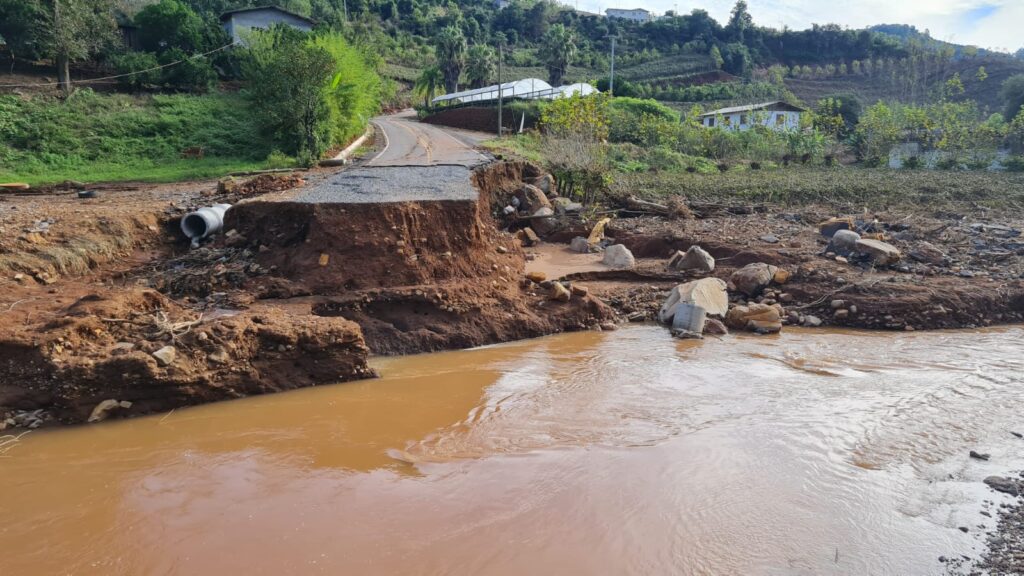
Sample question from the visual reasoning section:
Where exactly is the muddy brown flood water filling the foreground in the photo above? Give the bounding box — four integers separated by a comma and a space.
0, 326, 1024, 575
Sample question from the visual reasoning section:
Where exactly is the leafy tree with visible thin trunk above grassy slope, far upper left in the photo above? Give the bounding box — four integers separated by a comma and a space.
39, 0, 118, 94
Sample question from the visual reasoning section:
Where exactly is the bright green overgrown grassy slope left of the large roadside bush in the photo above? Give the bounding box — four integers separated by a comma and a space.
0, 90, 273, 184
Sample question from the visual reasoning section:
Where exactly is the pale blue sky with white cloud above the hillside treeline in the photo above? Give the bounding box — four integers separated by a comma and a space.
562, 0, 1024, 51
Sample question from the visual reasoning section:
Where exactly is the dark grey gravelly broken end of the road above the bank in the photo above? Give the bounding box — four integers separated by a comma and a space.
294, 165, 478, 204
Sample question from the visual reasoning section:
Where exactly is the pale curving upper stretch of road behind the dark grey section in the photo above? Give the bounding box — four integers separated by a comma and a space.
367, 111, 487, 167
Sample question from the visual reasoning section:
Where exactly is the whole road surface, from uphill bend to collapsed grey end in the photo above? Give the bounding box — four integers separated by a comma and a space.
293, 112, 487, 204
